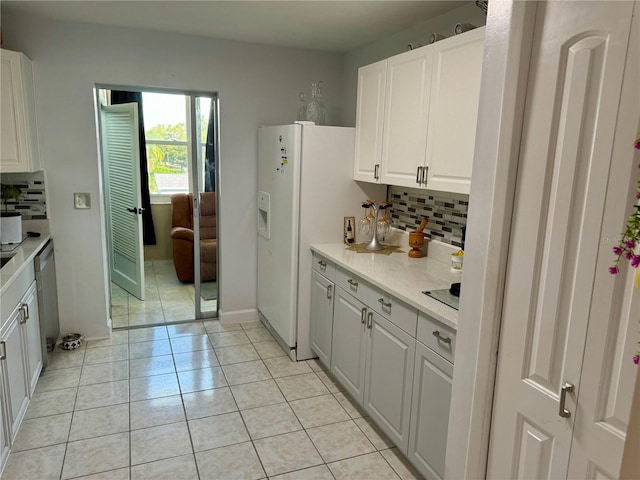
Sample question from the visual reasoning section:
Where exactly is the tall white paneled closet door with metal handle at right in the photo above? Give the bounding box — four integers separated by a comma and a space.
487, 2, 638, 479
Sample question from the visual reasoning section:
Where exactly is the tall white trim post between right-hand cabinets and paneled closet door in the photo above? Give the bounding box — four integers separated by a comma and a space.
445, 0, 536, 479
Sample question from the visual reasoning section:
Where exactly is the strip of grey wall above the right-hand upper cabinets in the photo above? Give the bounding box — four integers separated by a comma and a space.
342, 2, 487, 126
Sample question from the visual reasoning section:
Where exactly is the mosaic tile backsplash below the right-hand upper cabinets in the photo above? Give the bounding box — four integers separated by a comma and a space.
388, 186, 469, 247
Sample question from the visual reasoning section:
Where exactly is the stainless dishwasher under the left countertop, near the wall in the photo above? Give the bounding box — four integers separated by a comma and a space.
35, 240, 60, 369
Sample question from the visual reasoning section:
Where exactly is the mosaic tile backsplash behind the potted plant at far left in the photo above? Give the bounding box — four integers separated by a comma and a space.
1, 172, 47, 220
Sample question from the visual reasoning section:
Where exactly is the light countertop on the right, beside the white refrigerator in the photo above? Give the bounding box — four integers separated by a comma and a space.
311, 243, 459, 329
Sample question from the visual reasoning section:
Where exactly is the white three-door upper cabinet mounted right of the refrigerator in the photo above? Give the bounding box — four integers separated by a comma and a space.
354, 27, 485, 194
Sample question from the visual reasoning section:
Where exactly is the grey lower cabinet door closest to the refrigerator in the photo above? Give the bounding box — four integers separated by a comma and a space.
311, 272, 334, 367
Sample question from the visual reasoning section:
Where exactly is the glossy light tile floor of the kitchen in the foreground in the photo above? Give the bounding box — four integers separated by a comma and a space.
2, 320, 420, 480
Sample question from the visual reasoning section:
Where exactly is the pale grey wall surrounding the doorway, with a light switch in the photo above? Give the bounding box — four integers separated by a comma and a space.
2, 13, 342, 337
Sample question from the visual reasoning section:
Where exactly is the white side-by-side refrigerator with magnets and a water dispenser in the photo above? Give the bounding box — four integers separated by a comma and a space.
257, 124, 386, 360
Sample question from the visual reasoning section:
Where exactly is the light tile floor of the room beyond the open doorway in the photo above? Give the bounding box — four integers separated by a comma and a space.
111, 260, 217, 329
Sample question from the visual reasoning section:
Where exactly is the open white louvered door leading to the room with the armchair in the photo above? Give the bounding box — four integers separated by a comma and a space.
100, 103, 145, 300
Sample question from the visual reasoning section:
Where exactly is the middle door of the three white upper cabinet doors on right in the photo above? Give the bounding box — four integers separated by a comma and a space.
381, 47, 431, 187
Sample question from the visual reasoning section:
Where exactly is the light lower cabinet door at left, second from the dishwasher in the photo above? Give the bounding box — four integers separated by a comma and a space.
0, 307, 29, 440
